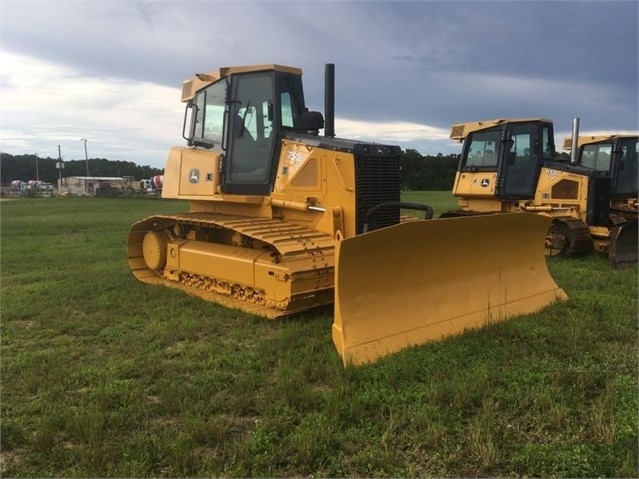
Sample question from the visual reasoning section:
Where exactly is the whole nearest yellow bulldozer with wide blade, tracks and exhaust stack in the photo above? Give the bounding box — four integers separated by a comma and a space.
127, 64, 566, 364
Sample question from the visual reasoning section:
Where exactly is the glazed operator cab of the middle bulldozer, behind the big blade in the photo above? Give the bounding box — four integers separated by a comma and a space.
451, 119, 554, 199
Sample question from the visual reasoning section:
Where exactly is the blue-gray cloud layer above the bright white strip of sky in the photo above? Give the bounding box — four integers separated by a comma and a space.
1, 1, 639, 165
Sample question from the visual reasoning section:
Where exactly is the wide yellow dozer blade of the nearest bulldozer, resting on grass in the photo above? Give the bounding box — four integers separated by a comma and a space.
333, 213, 567, 364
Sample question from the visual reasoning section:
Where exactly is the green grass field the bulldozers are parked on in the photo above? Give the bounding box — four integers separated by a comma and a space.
0, 192, 639, 477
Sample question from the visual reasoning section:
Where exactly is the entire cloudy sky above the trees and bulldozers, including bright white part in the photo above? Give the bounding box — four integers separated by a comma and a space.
0, 0, 639, 168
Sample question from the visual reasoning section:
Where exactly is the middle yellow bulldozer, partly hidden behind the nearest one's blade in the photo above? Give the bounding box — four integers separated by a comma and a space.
442, 118, 637, 267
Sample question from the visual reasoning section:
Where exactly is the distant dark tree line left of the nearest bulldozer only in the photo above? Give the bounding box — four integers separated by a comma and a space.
0, 153, 162, 185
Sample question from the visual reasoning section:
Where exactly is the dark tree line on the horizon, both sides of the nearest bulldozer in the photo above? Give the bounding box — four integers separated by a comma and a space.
0, 149, 459, 190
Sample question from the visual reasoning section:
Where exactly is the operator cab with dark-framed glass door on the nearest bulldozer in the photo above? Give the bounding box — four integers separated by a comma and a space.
183, 65, 323, 195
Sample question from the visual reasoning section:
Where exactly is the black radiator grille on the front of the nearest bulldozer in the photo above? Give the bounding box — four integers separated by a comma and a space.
355, 155, 400, 234
